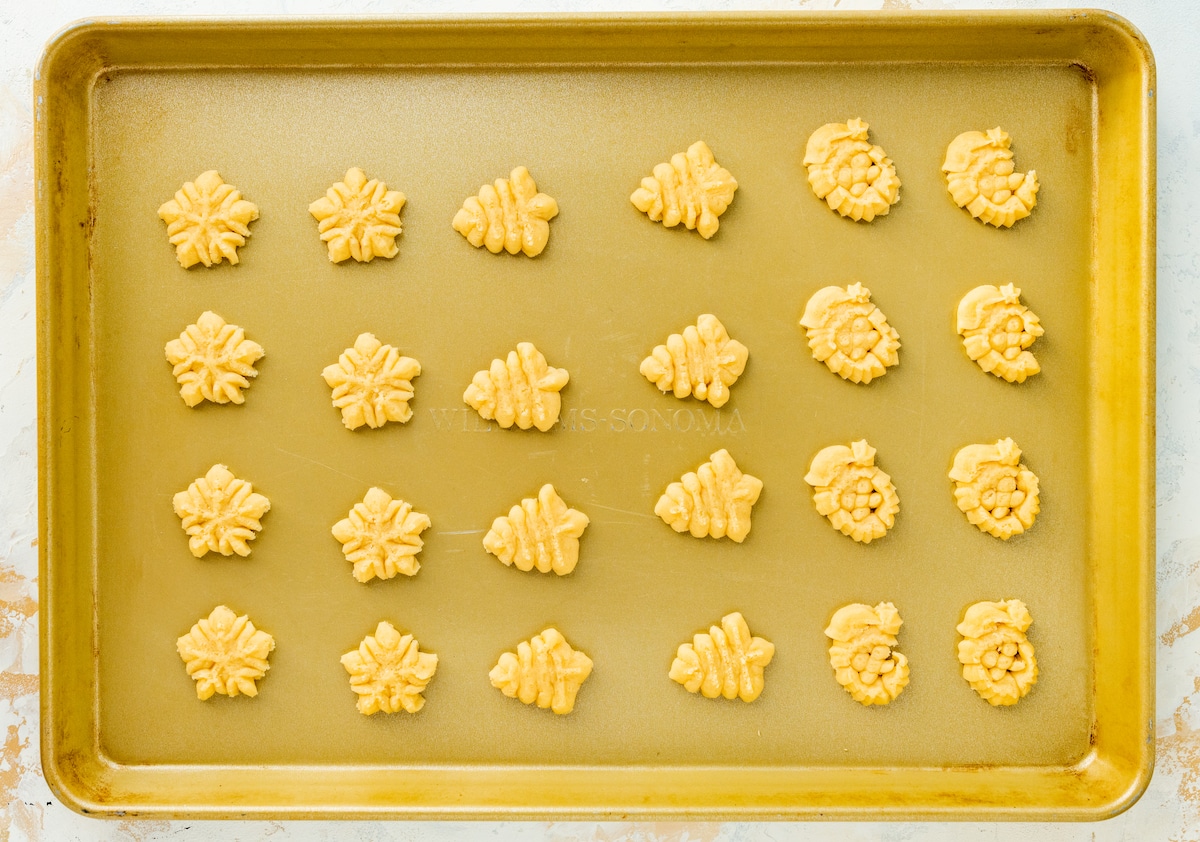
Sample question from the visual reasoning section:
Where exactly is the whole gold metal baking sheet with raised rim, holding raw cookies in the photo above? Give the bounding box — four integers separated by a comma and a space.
38, 13, 1153, 818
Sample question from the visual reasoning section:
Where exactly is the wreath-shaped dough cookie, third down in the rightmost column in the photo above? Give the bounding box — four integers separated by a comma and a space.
950, 439, 1042, 541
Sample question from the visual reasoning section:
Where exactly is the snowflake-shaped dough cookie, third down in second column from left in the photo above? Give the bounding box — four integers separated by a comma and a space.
332, 488, 430, 582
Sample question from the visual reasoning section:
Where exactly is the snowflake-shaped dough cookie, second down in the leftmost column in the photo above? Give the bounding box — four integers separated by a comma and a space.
163, 311, 264, 407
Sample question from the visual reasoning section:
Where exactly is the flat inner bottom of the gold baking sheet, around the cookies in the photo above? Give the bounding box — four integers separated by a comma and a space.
43, 11, 1152, 813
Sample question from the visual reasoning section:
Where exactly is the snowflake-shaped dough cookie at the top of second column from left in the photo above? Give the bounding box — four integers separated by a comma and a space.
308, 167, 404, 263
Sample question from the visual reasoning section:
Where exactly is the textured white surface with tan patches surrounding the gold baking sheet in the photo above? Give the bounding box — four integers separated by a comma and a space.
0, 0, 1200, 842
